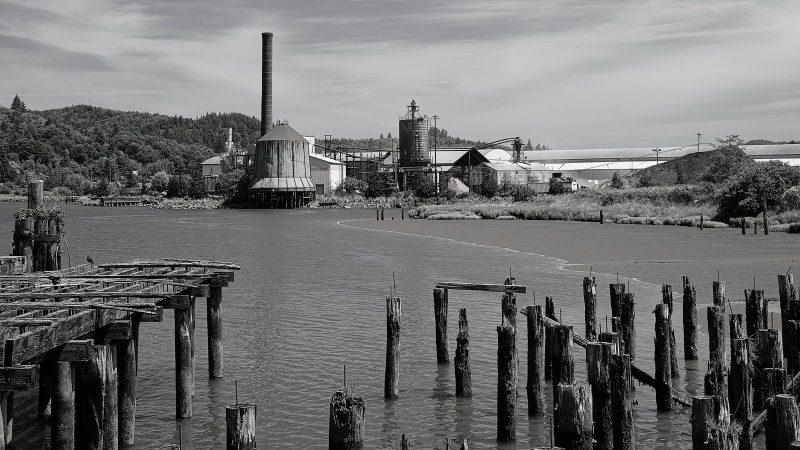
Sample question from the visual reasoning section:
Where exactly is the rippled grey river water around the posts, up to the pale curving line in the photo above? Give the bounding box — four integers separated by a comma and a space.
0, 204, 776, 449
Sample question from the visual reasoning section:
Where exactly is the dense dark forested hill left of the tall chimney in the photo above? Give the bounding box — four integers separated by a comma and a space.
0, 97, 259, 194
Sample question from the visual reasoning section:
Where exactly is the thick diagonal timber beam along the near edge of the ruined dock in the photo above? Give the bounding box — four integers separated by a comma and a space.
3, 309, 122, 367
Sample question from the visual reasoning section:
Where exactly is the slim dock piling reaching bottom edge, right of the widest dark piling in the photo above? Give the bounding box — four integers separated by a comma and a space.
117, 314, 140, 447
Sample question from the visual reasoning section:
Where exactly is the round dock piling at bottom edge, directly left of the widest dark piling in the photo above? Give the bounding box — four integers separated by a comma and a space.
50, 361, 75, 450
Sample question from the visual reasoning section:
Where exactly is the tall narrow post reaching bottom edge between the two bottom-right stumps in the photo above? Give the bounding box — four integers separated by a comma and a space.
728, 338, 753, 450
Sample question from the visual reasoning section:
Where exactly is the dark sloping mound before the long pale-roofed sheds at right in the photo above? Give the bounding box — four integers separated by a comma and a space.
626, 146, 755, 186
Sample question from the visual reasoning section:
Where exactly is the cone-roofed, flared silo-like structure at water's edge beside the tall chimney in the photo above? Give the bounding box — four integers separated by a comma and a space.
250, 123, 316, 208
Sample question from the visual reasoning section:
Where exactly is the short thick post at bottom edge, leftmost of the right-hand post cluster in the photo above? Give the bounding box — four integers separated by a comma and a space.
554, 383, 592, 450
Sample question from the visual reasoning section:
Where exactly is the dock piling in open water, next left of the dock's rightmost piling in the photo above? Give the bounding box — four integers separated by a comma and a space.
174, 309, 193, 419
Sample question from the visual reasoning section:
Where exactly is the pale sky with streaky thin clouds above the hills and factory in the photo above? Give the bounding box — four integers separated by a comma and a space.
0, 0, 800, 149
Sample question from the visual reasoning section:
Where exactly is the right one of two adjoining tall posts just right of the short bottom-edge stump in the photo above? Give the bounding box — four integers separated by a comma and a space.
608, 355, 636, 450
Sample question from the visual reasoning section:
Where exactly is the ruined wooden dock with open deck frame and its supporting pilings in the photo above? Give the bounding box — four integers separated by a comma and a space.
0, 260, 239, 448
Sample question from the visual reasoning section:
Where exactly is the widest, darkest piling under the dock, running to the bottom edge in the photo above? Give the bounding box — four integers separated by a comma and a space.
75, 345, 108, 450
